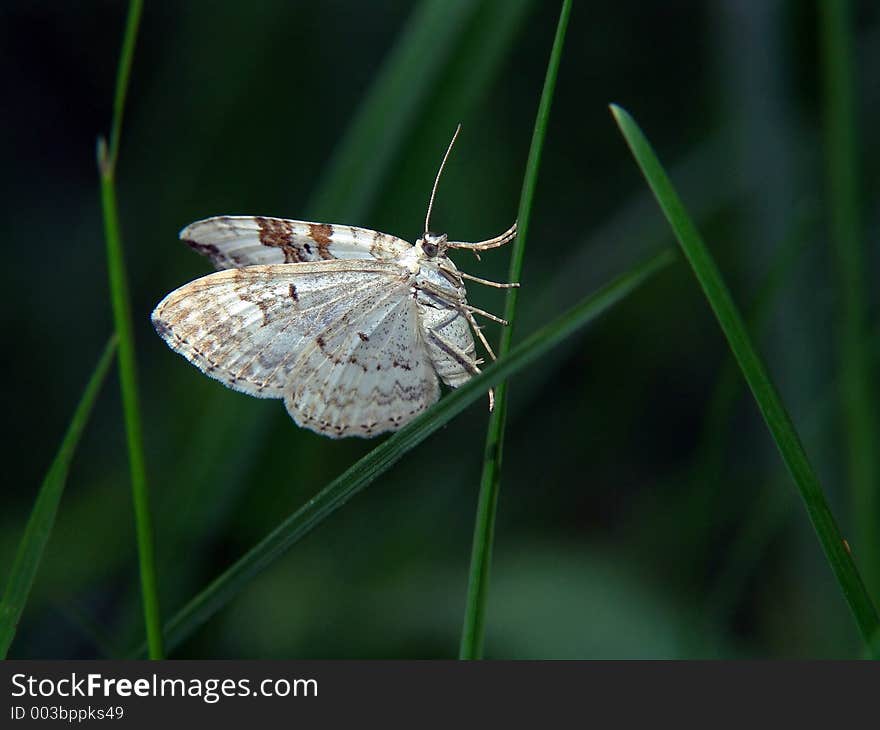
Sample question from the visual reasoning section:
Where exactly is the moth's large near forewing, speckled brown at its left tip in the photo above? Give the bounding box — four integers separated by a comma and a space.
152, 261, 408, 398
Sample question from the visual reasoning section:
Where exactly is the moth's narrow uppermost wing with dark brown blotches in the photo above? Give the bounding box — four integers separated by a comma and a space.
180, 216, 412, 269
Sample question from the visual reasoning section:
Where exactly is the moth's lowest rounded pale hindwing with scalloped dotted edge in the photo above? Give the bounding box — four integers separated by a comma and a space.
284, 286, 440, 437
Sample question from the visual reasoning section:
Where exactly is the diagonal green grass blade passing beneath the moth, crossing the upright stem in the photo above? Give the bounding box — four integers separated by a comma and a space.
134, 251, 674, 652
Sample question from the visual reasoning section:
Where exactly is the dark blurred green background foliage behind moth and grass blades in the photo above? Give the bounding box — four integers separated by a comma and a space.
0, 0, 880, 658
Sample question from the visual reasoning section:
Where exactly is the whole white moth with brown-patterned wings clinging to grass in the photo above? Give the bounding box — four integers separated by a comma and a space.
152, 125, 518, 438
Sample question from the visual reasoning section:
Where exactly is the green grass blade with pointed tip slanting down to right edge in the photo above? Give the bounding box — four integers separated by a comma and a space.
611, 105, 880, 650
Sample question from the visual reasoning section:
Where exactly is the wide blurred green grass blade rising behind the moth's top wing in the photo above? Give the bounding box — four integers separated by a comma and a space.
309, 0, 478, 221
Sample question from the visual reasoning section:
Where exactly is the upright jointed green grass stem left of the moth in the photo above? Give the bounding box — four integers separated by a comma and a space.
98, 0, 164, 659
